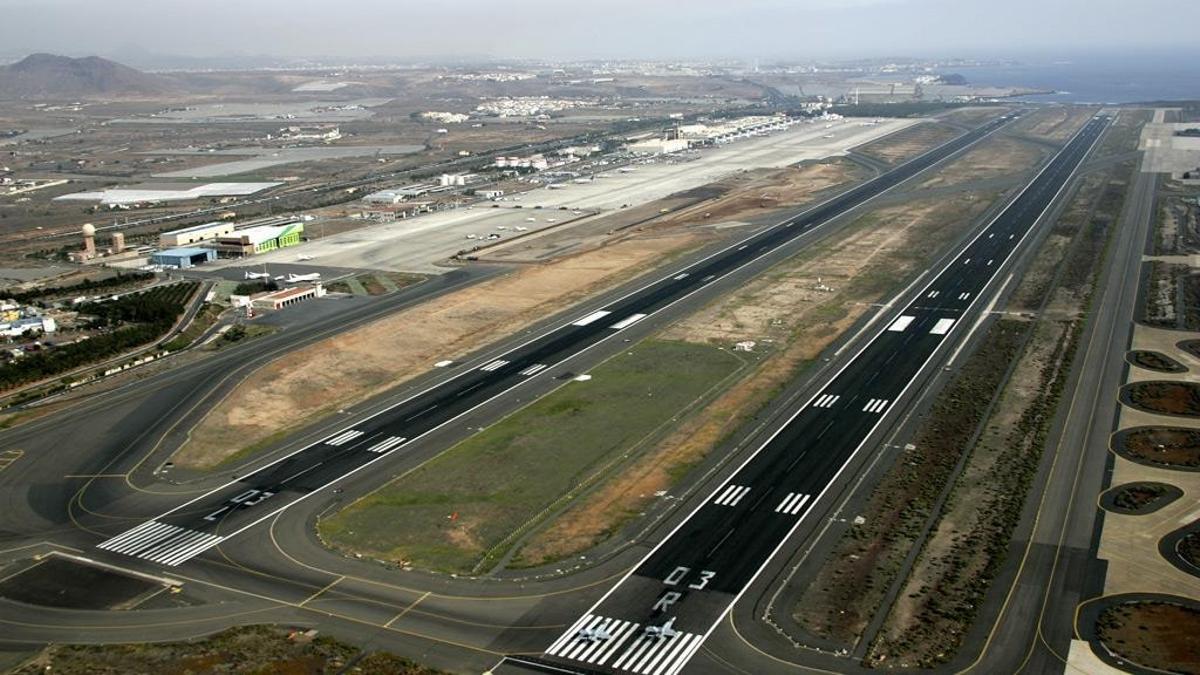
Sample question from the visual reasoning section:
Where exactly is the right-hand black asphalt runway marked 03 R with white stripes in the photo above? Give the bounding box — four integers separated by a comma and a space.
530, 117, 1109, 675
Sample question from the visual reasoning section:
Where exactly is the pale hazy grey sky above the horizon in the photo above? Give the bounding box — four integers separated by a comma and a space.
0, 0, 1200, 59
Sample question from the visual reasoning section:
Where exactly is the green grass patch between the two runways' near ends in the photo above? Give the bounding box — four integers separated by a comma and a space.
320, 341, 742, 573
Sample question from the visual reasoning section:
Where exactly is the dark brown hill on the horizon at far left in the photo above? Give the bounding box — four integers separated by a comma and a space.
0, 54, 175, 98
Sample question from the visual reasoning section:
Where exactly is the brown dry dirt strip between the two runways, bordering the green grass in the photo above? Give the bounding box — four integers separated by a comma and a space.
521, 195, 990, 562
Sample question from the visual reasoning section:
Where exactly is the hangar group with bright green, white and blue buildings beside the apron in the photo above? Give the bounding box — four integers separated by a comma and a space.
150, 216, 304, 269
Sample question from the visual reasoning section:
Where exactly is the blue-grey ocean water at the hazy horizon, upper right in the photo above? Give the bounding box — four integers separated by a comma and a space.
953, 54, 1200, 103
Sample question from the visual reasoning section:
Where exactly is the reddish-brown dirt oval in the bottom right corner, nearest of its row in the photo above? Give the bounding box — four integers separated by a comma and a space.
1096, 602, 1200, 674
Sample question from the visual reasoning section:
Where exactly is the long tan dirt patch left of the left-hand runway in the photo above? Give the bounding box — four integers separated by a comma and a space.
174, 229, 704, 468
